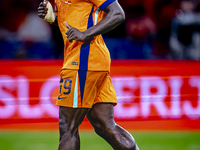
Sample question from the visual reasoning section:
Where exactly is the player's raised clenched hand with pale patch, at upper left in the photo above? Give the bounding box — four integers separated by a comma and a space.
38, 0, 55, 23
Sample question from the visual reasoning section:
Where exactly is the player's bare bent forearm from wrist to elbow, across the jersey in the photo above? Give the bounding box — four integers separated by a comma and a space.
85, 3, 125, 39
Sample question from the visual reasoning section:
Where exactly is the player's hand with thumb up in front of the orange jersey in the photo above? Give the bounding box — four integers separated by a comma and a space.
65, 22, 87, 42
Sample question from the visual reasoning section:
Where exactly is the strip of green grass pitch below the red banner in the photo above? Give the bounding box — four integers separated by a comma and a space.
0, 131, 200, 150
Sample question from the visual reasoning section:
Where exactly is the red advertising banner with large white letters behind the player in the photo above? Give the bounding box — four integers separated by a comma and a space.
0, 60, 200, 131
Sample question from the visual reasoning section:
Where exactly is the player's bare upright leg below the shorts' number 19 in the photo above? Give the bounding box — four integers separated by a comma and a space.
58, 107, 88, 150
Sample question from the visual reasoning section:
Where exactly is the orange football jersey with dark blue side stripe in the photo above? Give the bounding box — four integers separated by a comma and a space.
55, 0, 115, 71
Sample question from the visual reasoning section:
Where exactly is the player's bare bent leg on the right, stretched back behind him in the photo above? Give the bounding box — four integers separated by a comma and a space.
87, 103, 139, 150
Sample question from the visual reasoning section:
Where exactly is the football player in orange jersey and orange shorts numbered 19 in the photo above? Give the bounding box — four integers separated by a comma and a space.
38, 0, 139, 150
